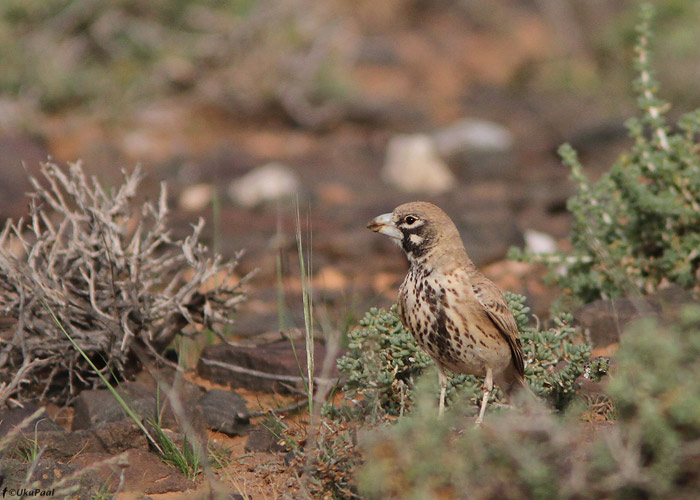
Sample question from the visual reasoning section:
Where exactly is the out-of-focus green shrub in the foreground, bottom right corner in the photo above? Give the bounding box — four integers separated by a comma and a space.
357, 308, 700, 500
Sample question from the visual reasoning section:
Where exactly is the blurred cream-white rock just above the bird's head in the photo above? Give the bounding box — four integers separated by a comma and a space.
382, 134, 455, 195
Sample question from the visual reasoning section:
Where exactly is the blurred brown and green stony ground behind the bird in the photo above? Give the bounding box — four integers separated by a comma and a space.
0, 0, 700, 335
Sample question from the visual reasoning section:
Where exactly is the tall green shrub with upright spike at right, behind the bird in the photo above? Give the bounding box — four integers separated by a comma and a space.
511, 5, 700, 303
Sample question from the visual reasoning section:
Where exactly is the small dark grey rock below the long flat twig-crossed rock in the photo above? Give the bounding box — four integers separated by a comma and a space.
197, 389, 250, 436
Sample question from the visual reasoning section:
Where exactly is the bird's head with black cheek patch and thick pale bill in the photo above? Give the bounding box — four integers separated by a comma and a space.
367, 201, 464, 263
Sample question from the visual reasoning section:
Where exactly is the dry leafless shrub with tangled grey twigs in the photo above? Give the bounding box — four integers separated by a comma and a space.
0, 163, 252, 403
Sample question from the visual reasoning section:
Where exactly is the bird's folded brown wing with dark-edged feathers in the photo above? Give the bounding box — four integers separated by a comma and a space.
471, 273, 525, 375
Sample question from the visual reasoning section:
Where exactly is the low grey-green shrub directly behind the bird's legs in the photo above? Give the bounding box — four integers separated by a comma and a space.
338, 293, 590, 415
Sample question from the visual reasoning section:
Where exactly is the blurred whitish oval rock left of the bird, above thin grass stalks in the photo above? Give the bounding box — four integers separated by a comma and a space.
228, 162, 301, 208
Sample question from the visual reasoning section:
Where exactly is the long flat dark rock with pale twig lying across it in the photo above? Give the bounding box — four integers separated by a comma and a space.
197, 341, 338, 392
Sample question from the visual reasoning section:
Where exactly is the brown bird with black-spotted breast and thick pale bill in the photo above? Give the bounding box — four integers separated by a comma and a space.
367, 201, 528, 425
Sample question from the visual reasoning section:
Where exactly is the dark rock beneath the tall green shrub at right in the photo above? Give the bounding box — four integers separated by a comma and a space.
574, 286, 697, 348
